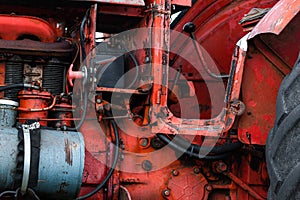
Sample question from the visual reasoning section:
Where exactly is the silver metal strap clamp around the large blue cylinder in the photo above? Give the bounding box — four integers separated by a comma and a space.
21, 122, 40, 194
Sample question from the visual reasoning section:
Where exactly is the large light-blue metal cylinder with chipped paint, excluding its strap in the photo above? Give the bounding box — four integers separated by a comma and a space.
0, 127, 84, 199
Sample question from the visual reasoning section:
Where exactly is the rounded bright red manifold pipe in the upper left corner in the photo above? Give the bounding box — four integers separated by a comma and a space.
0, 15, 57, 42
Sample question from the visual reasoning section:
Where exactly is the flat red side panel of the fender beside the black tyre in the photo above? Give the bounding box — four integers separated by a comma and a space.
239, 4, 300, 145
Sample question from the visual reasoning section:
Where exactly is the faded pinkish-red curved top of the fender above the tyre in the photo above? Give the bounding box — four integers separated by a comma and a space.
249, 0, 300, 39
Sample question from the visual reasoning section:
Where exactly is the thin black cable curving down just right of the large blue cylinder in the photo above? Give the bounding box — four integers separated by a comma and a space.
76, 120, 119, 200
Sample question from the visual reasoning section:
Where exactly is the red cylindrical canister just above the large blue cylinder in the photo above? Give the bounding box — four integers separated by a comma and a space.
18, 90, 51, 126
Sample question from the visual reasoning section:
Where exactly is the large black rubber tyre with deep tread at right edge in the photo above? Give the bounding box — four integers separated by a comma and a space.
266, 56, 300, 200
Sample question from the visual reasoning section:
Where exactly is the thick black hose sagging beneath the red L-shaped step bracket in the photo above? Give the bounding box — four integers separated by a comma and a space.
156, 133, 240, 160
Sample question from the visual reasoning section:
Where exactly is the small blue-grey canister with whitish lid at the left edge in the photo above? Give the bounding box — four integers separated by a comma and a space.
0, 99, 19, 127
